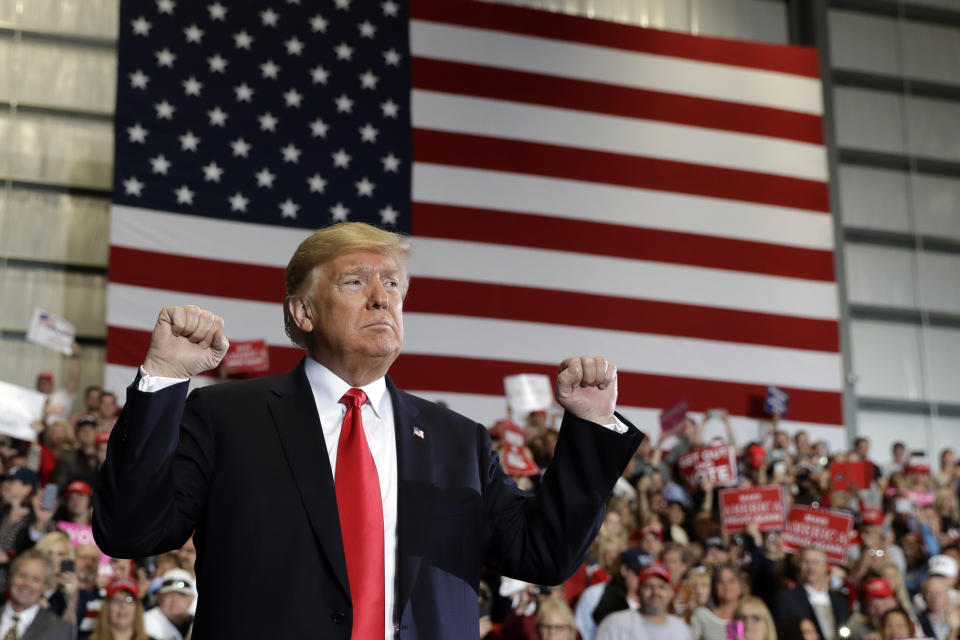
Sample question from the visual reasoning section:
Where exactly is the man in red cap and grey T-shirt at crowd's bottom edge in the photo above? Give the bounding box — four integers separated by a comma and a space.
596, 564, 692, 640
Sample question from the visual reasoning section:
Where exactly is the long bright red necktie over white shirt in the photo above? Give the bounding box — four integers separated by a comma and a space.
334, 389, 386, 640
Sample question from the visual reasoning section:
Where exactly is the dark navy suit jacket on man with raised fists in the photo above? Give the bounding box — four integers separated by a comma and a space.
93, 362, 643, 640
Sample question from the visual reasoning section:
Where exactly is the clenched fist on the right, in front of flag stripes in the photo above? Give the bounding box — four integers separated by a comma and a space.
557, 356, 617, 424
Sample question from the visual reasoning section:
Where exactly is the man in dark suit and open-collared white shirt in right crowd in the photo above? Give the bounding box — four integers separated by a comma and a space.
776, 548, 850, 640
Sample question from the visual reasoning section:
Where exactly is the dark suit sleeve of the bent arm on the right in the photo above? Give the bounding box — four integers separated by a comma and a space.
480, 413, 644, 585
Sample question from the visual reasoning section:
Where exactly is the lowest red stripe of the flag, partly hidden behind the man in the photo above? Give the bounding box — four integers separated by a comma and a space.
107, 327, 843, 425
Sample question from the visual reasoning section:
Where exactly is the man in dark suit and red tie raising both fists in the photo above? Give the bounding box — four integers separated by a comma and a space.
94, 223, 643, 640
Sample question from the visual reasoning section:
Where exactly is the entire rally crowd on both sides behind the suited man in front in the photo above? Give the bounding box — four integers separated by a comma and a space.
0, 364, 960, 640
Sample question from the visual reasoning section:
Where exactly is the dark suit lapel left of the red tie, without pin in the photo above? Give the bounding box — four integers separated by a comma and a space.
269, 360, 350, 596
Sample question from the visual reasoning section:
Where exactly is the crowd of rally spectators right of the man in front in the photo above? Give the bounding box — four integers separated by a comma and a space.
481, 410, 960, 640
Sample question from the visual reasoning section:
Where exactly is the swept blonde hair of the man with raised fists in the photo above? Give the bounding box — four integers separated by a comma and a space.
283, 222, 411, 348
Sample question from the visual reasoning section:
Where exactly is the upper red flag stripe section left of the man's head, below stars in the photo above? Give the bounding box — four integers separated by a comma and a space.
108, 246, 286, 304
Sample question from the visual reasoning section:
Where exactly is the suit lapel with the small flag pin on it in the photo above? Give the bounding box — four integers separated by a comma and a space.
387, 377, 432, 616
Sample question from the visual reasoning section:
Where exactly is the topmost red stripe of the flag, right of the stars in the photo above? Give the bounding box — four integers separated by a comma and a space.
410, 0, 820, 79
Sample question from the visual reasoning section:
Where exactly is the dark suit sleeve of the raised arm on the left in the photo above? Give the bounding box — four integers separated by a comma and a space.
93, 381, 213, 558
